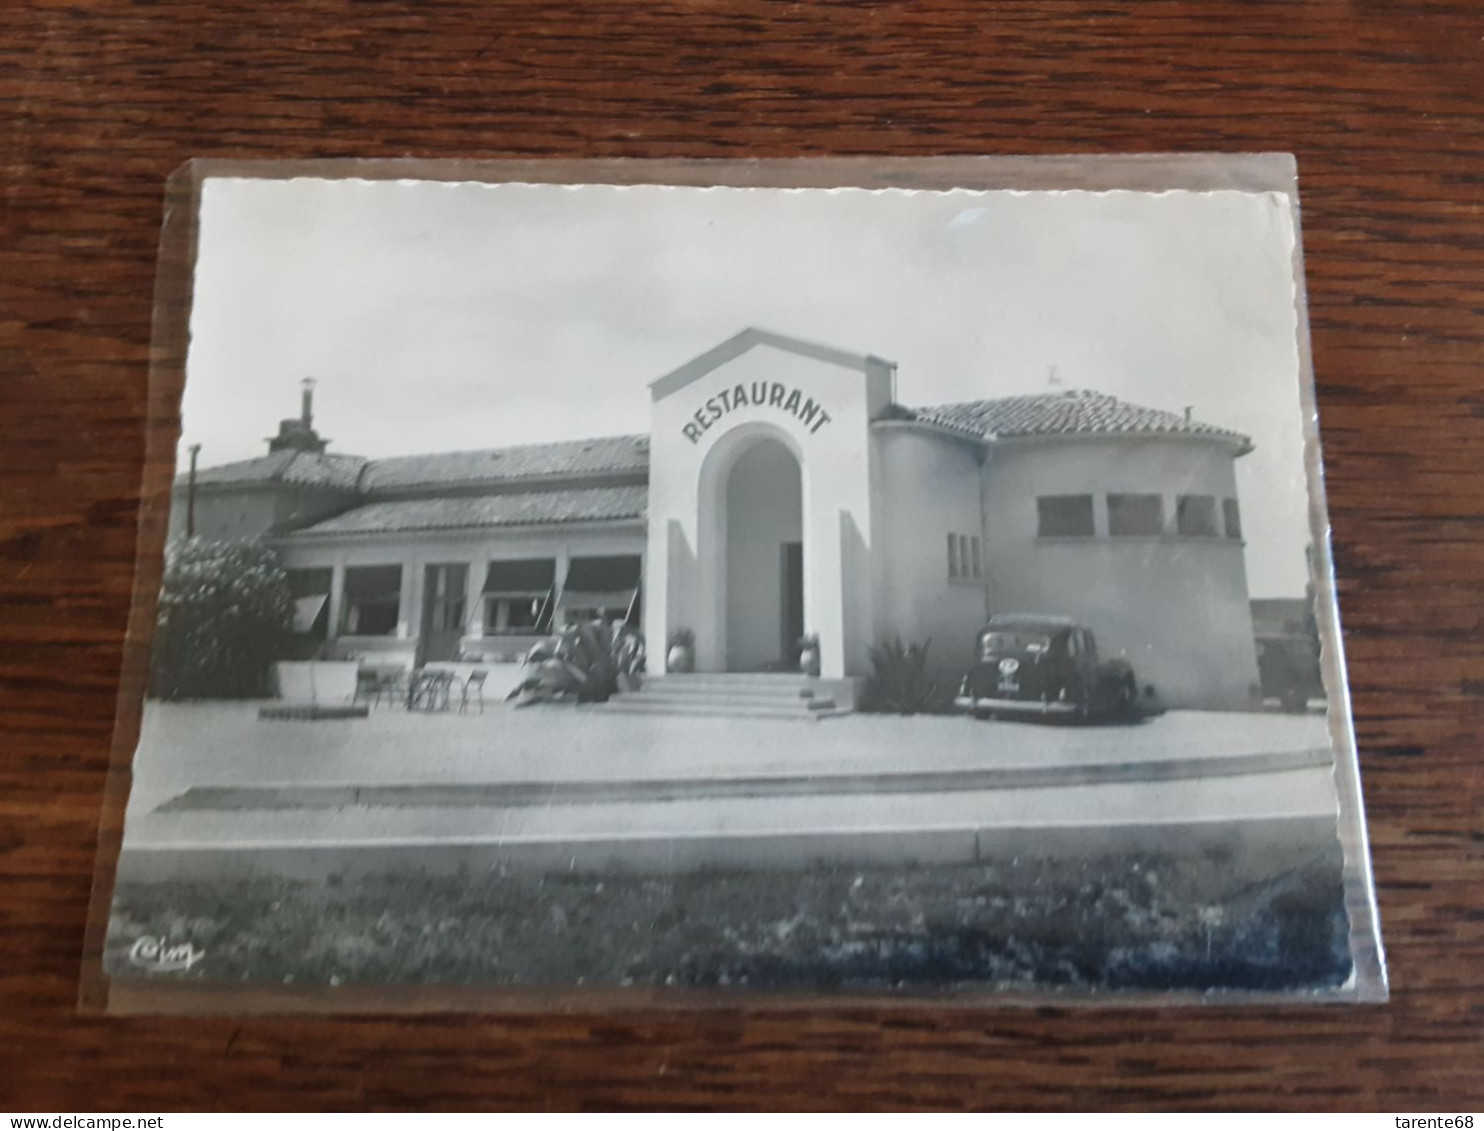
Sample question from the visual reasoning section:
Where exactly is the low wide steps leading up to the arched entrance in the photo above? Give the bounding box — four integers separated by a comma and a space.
597, 672, 855, 720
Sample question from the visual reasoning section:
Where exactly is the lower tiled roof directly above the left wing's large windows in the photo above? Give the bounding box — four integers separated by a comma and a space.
288, 484, 649, 539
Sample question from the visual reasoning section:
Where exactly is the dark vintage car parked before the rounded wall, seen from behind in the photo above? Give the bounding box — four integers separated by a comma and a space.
954, 613, 1155, 718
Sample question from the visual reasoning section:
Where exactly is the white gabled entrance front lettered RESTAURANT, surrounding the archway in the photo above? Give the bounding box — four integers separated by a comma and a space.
644, 331, 893, 678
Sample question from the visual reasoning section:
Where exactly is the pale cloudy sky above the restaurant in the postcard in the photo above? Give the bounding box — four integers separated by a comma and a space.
181, 178, 1309, 597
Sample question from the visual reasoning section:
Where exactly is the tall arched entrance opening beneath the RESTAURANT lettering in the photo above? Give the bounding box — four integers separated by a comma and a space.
721, 436, 804, 671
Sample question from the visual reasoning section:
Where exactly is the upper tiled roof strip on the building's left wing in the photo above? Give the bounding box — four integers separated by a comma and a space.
362, 436, 649, 496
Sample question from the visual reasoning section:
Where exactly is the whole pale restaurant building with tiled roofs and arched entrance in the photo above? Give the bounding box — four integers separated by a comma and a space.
171, 330, 1257, 708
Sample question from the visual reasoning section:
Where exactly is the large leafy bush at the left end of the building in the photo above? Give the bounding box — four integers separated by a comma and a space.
150, 539, 294, 699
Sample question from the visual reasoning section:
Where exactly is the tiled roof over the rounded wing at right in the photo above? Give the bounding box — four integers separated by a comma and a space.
908, 389, 1252, 451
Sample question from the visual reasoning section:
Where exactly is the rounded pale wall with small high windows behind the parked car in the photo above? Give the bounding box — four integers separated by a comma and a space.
984, 436, 1257, 708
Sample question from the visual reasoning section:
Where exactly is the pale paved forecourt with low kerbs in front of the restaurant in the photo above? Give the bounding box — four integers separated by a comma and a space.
120, 704, 1336, 879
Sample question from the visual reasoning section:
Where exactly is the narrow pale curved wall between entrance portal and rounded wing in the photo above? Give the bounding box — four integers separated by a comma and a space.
876, 423, 987, 675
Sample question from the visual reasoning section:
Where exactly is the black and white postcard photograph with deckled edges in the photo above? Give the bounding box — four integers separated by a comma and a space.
104, 161, 1385, 1008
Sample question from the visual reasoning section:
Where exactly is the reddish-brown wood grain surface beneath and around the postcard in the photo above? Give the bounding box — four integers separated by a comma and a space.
0, 0, 1484, 1112
